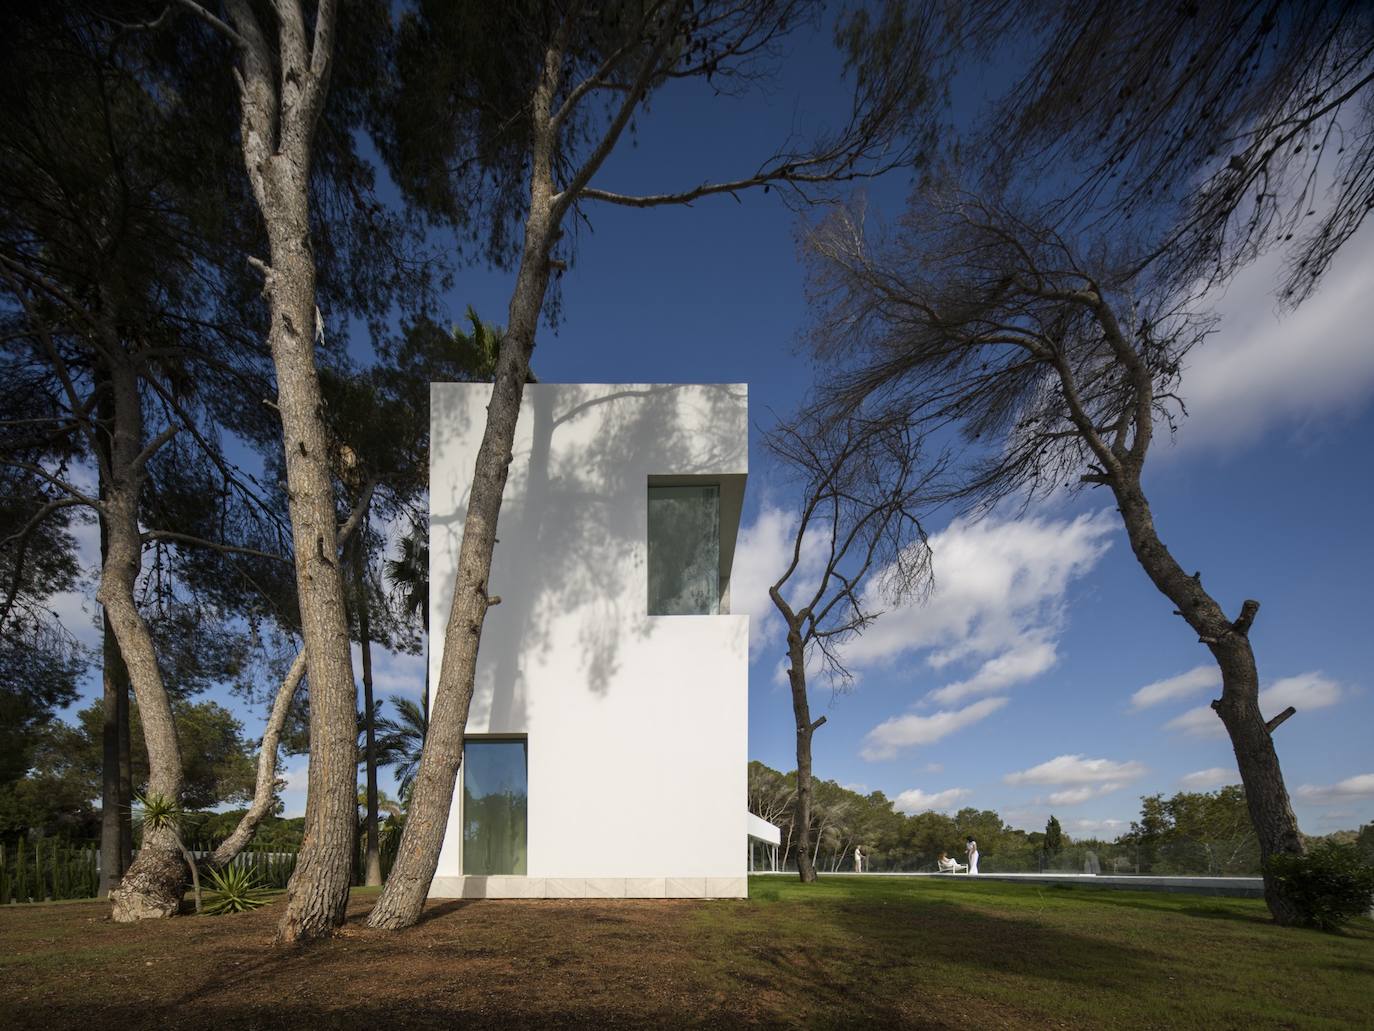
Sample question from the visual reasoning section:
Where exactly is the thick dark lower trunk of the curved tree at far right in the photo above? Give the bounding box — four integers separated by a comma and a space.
1112, 477, 1303, 925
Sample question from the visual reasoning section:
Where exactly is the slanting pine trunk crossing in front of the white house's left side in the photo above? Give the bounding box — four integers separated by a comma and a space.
367, 51, 561, 931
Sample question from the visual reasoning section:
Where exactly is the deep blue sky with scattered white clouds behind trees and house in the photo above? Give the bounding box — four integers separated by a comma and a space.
48, 16, 1374, 837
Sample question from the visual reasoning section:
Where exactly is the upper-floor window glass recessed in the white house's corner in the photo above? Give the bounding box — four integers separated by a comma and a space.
649, 485, 720, 616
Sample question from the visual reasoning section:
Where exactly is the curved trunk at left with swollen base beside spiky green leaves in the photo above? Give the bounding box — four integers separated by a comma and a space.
96, 363, 185, 924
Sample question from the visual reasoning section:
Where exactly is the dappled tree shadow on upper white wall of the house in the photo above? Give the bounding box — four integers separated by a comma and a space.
431, 384, 747, 733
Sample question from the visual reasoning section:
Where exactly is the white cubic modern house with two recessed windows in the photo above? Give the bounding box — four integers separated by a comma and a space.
430, 384, 752, 898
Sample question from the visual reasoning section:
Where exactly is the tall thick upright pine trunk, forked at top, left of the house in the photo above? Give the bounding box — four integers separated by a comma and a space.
227, 0, 357, 944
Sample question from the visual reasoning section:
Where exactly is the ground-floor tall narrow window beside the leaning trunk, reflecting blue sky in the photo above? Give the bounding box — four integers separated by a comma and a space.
463, 741, 529, 874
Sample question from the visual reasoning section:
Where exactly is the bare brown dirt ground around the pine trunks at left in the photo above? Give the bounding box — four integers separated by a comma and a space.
0, 895, 818, 1031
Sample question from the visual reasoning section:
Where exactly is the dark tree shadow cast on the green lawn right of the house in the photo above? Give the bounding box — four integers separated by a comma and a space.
687, 892, 1172, 1027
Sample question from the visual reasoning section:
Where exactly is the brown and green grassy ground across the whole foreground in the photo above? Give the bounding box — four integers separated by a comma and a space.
0, 877, 1374, 1031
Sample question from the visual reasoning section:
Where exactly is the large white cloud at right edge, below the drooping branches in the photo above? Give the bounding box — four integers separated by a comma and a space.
1179, 219, 1374, 448
